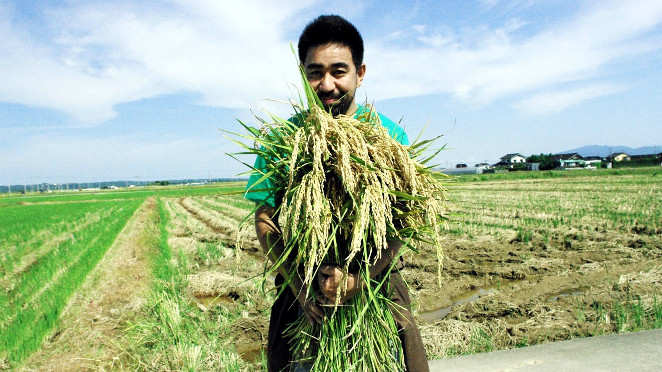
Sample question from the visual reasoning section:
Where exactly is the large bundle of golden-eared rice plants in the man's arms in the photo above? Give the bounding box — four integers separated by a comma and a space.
228, 56, 448, 371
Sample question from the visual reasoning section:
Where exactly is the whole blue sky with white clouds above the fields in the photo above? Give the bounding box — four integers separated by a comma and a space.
0, 0, 662, 184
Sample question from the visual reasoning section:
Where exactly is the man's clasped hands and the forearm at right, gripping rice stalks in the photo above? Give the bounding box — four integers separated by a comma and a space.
317, 240, 402, 305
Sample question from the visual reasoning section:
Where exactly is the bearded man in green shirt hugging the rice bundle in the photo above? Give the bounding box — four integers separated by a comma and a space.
246, 16, 428, 372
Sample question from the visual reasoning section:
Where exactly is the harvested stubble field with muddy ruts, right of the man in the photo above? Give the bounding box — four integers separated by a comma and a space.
412, 173, 662, 358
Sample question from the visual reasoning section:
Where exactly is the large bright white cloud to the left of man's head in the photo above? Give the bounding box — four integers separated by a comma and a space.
0, 0, 310, 124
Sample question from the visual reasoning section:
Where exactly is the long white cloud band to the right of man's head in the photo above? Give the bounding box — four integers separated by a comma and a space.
366, 1, 662, 113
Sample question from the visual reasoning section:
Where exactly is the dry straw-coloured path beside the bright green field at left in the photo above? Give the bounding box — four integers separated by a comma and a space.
23, 198, 158, 371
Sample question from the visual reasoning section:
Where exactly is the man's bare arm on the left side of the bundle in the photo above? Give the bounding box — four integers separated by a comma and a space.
255, 205, 324, 325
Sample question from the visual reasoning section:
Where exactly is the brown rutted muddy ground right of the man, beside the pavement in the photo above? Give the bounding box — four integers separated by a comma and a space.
404, 233, 662, 358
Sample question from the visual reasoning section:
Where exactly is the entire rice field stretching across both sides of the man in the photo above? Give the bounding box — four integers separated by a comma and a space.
0, 167, 662, 371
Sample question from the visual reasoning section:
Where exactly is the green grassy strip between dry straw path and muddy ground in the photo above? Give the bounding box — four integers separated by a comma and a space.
123, 199, 262, 372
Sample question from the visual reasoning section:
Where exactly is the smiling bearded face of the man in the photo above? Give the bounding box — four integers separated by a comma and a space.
303, 43, 365, 116
